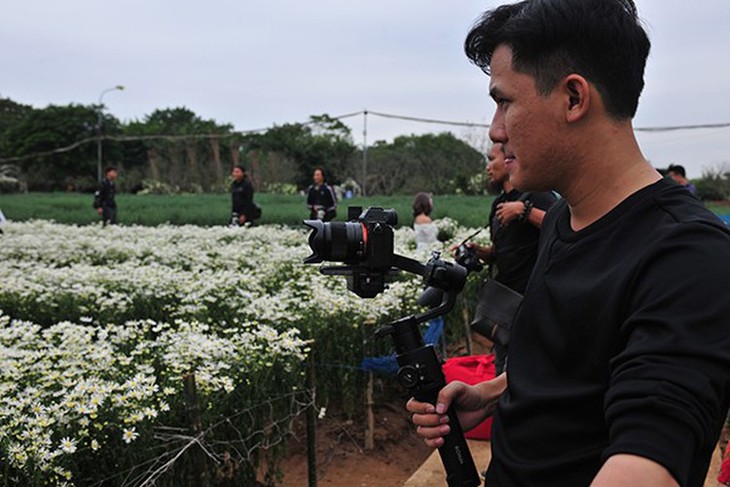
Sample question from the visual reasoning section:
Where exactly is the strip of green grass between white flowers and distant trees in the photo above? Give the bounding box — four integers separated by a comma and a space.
0, 193, 492, 227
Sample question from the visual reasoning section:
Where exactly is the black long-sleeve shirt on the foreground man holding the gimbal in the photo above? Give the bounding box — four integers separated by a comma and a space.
487, 180, 730, 487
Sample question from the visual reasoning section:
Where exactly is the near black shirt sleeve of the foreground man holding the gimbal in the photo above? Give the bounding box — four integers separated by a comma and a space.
603, 223, 730, 485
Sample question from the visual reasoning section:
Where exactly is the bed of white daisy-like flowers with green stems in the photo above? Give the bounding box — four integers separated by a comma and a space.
0, 221, 484, 485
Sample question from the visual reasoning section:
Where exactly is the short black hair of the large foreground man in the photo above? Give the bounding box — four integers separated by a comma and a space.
464, 0, 650, 119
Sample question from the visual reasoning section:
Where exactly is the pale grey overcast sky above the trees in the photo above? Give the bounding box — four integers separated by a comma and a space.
0, 0, 730, 177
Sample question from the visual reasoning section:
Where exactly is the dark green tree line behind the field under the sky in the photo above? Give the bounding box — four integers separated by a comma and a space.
0, 98, 485, 195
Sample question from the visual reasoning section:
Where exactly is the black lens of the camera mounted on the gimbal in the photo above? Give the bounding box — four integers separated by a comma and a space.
304, 220, 367, 264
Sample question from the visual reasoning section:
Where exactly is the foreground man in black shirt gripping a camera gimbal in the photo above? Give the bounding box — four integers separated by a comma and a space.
407, 0, 730, 487
